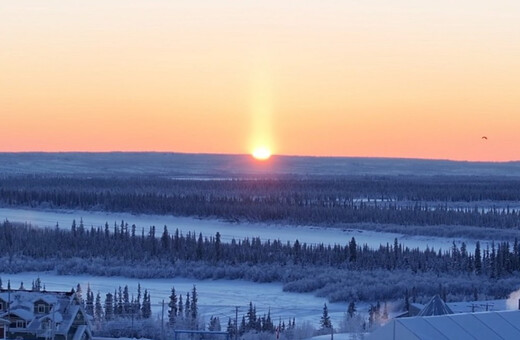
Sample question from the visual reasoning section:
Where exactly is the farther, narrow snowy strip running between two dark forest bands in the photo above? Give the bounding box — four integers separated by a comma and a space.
0, 208, 485, 251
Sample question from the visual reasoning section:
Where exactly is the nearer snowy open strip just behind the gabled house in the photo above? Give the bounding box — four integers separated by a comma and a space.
1, 272, 347, 327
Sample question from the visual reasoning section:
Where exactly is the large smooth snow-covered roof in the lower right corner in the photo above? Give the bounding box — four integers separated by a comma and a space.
366, 310, 520, 340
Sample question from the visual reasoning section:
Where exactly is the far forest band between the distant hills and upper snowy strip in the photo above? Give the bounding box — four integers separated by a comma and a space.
0, 176, 520, 228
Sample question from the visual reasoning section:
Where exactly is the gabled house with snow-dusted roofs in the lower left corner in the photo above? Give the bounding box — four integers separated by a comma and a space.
0, 289, 92, 340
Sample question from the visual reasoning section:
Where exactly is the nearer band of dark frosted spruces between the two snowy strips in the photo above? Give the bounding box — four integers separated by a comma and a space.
0, 221, 520, 302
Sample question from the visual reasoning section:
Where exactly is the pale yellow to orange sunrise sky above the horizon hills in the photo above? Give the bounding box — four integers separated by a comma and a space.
0, 0, 520, 161
